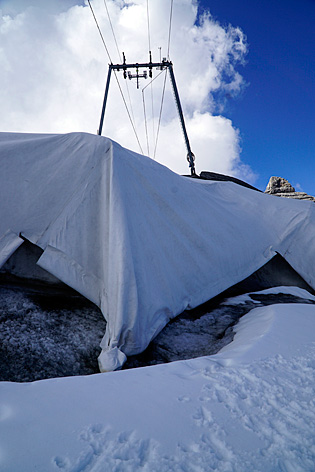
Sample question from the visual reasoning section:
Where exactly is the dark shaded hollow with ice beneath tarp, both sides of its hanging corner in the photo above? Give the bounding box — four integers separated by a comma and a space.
0, 241, 314, 382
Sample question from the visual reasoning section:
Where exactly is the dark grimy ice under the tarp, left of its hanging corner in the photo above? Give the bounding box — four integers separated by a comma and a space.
0, 287, 106, 382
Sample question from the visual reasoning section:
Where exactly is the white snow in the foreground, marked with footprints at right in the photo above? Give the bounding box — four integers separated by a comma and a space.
0, 296, 315, 472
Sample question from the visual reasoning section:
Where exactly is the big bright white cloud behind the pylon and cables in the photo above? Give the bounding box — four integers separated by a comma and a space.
0, 0, 253, 180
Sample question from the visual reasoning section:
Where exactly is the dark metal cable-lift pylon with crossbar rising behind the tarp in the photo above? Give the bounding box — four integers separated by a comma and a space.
97, 53, 196, 175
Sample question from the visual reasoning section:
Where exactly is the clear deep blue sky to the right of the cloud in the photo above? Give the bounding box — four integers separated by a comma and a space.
201, 0, 315, 195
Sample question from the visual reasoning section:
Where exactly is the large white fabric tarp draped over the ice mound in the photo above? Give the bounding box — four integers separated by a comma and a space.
0, 133, 315, 371
